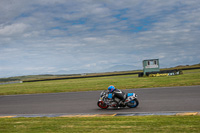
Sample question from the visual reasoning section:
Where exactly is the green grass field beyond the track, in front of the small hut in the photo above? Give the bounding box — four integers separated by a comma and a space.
0, 69, 200, 95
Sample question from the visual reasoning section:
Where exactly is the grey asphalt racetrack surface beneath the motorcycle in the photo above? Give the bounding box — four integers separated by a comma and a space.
0, 86, 200, 115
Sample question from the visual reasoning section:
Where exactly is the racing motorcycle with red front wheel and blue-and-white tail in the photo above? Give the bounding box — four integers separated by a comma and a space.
97, 90, 139, 109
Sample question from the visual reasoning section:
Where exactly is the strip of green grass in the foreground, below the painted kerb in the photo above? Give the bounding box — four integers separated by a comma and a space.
0, 116, 200, 133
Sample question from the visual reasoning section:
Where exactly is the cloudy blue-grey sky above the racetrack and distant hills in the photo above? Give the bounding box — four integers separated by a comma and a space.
0, 0, 200, 78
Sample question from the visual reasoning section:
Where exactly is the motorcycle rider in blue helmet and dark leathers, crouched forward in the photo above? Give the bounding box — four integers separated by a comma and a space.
108, 85, 126, 105
